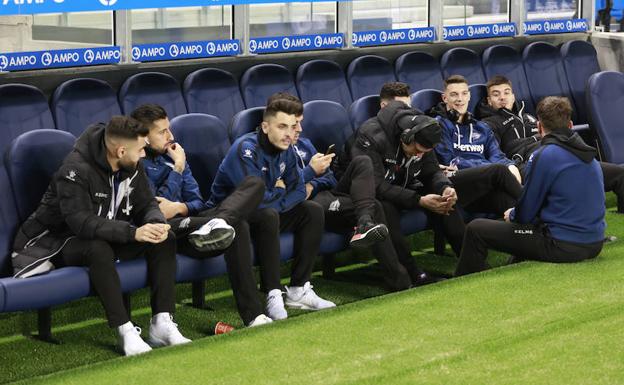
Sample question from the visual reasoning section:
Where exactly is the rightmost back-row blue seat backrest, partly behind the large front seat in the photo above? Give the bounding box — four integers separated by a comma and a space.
561, 40, 600, 124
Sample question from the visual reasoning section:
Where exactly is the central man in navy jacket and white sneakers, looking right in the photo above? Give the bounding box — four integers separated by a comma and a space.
209, 100, 335, 319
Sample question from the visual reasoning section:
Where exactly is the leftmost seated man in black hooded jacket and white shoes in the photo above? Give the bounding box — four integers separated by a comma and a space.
12, 116, 190, 355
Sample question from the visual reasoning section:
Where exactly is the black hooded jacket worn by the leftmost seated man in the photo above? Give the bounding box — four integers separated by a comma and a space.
12, 124, 166, 276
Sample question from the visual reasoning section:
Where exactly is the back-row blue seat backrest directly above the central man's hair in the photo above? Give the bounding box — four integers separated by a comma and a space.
240, 64, 299, 108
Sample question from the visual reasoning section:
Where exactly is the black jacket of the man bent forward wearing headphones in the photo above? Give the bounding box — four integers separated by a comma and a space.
339, 101, 453, 208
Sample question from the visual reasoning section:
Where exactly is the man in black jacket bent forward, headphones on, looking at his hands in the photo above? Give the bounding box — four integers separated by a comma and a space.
339, 83, 464, 258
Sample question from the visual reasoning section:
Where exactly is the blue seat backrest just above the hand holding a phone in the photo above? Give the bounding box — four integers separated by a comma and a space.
301, 100, 353, 152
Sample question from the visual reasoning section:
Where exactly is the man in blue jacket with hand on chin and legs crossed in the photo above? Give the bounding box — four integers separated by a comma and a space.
132, 104, 276, 325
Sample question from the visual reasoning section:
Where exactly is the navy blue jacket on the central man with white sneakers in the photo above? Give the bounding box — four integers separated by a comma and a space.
208, 130, 306, 213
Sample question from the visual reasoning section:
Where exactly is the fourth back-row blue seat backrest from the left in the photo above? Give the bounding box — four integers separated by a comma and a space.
182, 68, 245, 126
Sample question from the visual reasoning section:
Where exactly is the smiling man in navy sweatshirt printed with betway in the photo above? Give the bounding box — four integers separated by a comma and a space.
429, 75, 522, 215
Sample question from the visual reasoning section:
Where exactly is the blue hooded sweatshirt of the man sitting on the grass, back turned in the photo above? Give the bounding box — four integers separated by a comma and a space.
510, 129, 606, 243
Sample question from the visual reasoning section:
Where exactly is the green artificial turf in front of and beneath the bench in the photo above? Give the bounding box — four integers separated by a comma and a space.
0, 199, 624, 384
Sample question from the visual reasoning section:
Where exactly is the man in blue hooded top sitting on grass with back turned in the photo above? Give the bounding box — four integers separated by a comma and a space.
455, 96, 606, 275
